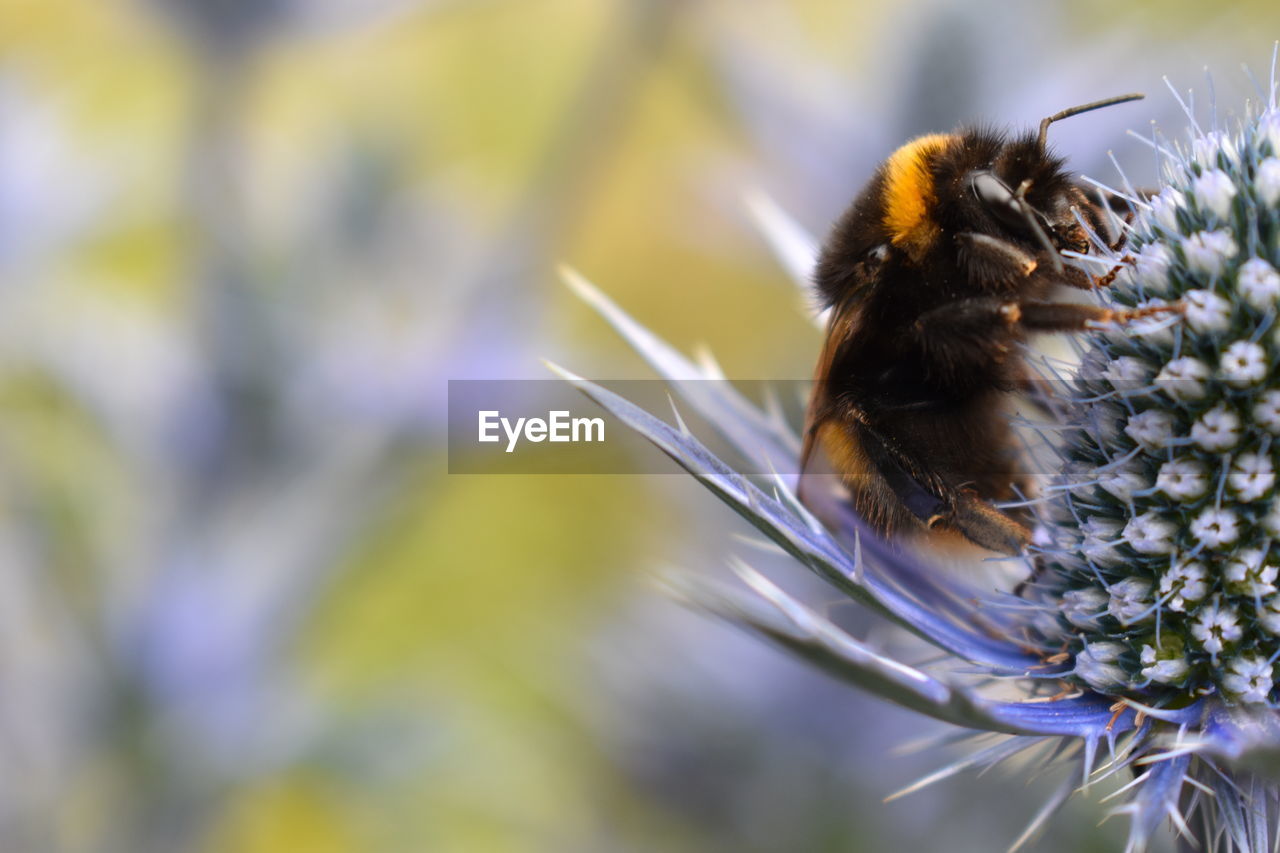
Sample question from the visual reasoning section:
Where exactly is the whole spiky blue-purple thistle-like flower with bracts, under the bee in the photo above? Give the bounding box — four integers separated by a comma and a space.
552, 76, 1280, 850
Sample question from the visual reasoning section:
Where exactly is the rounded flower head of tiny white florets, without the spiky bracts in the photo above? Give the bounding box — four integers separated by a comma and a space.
1042, 96, 1280, 707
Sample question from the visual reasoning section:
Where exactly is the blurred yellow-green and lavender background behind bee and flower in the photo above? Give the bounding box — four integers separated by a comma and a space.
0, 0, 1280, 853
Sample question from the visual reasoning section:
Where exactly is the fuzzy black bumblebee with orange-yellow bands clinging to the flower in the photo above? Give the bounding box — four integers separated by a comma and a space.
800, 95, 1176, 555
